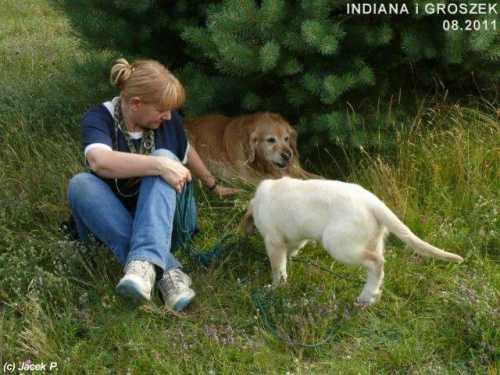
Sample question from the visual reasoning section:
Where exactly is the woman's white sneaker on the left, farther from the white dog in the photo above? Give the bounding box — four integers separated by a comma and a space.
115, 260, 156, 301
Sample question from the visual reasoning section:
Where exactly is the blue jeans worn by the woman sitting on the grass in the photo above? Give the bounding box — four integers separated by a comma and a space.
68, 149, 196, 276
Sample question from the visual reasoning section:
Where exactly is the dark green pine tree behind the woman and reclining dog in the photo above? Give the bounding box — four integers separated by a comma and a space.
59, 0, 500, 151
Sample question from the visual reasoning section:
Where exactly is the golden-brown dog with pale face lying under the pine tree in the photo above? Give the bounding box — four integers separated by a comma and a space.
184, 112, 318, 182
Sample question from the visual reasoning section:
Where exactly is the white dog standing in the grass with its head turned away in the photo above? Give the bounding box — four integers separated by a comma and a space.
243, 177, 463, 304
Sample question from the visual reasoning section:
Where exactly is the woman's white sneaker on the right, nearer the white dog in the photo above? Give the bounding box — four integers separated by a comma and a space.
158, 268, 196, 311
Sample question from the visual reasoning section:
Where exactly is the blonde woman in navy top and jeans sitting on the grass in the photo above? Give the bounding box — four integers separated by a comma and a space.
68, 59, 235, 310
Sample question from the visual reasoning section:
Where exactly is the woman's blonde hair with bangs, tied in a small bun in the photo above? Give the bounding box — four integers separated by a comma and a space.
110, 58, 186, 109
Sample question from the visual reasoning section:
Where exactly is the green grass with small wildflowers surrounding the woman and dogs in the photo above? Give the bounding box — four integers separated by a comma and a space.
0, 0, 500, 374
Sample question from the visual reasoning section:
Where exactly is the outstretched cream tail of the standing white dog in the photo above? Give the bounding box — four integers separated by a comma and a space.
373, 202, 463, 263
